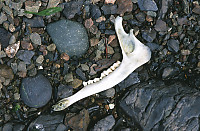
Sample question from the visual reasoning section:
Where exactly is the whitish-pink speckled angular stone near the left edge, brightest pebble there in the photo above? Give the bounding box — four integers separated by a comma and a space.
5, 41, 20, 58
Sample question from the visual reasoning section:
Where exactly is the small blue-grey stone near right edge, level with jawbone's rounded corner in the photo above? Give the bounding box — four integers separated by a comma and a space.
167, 39, 180, 52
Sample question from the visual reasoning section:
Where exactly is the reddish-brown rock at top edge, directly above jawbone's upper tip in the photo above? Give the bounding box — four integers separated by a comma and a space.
116, 0, 133, 15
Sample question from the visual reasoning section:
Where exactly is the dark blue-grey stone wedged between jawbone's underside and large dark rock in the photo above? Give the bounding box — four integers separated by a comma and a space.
118, 72, 140, 90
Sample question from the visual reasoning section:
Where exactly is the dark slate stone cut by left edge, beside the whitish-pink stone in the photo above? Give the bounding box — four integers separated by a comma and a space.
0, 28, 12, 49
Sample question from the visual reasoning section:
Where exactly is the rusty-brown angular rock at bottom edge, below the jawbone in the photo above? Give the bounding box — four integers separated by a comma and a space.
65, 109, 90, 131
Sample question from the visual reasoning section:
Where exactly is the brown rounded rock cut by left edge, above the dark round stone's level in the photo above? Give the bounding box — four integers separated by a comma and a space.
0, 65, 14, 80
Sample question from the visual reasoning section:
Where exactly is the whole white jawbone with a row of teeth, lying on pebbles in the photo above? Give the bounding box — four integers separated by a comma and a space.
52, 16, 151, 111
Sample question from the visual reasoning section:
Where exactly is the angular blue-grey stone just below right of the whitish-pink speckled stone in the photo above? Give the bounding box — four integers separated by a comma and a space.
16, 50, 35, 64
